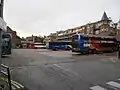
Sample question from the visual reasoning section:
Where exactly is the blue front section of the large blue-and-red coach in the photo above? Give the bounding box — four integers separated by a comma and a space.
72, 34, 89, 54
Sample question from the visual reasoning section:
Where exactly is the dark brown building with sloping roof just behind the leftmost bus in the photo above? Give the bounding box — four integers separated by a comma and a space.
7, 26, 21, 48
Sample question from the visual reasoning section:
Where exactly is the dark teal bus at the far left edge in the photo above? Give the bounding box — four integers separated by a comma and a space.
2, 33, 12, 55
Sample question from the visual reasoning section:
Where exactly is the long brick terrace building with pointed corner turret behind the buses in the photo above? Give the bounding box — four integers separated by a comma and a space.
45, 12, 117, 41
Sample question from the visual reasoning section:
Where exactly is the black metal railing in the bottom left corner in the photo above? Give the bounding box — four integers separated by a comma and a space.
1, 64, 12, 90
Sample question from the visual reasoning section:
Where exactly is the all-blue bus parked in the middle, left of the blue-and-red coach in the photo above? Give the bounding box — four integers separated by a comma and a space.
46, 41, 72, 50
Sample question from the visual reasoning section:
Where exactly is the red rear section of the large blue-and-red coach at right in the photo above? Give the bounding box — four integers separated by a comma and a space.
89, 36, 117, 53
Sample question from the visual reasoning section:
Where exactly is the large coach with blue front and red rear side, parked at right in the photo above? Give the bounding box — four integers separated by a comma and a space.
72, 34, 117, 54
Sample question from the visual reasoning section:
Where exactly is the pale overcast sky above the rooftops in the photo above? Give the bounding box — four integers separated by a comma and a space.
4, 0, 120, 37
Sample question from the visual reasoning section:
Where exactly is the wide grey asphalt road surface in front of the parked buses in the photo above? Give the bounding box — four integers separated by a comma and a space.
2, 49, 120, 90
